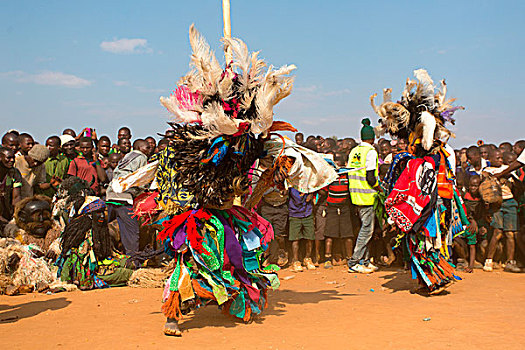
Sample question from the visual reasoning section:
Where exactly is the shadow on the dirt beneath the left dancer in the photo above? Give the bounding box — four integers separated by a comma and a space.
178, 289, 355, 329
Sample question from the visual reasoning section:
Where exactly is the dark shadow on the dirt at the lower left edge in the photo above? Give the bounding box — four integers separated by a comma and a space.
0, 297, 71, 324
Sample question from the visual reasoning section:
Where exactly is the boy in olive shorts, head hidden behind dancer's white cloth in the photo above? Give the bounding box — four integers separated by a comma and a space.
288, 188, 315, 272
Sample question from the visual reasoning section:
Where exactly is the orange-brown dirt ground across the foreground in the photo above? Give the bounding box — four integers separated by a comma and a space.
0, 267, 525, 349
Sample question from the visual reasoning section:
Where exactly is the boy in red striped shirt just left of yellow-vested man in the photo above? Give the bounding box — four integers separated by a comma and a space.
325, 153, 354, 268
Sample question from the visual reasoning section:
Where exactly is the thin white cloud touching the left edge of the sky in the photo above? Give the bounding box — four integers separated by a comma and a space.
0, 71, 93, 88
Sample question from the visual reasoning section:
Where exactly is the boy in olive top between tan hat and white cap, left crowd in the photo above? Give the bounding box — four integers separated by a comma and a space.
41, 136, 69, 198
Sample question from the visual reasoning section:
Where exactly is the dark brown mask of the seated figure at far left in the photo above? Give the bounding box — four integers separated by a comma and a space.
19, 200, 53, 238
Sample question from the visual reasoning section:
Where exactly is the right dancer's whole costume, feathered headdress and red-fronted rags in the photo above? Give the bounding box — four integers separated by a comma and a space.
370, 69, 468, 293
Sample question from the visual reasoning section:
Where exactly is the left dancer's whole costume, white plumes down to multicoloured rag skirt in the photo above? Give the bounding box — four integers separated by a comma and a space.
130, 26, 330, 320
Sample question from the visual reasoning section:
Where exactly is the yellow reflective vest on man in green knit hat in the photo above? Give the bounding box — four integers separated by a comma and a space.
348, 145, 379, 205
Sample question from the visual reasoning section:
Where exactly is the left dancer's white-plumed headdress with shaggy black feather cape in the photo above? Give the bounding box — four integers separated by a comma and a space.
157, 25, 295, 207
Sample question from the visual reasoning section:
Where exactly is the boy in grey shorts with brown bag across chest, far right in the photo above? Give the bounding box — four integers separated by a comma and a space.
483, 149, 521, 272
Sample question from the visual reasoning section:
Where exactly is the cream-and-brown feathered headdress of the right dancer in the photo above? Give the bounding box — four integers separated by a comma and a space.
370, 69, 465, 152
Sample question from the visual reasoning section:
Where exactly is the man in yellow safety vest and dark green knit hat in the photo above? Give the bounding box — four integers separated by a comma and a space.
348, 118, 381, 273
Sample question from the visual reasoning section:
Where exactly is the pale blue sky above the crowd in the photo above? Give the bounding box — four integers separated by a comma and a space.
0, 0, 525, 147
